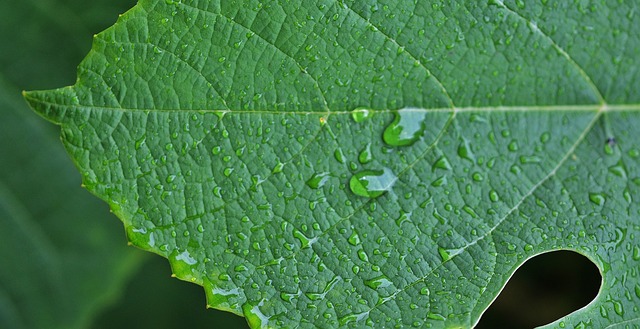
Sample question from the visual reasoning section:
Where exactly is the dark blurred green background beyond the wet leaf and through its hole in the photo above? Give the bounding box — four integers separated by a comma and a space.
0, 0, 600, 329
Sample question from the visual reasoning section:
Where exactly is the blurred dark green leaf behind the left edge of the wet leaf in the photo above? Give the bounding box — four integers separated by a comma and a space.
0, 1, 143, 329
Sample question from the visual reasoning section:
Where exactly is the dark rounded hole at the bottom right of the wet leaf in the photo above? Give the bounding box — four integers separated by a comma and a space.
475, 251, 602, 329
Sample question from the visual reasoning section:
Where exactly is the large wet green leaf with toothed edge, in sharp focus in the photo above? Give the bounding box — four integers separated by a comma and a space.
25, 0, 640, 328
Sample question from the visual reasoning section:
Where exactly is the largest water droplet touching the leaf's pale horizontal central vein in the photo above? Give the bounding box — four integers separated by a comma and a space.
383, 108, 427, 146
